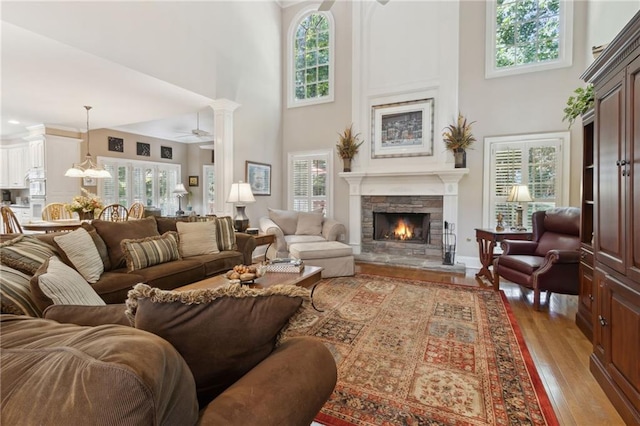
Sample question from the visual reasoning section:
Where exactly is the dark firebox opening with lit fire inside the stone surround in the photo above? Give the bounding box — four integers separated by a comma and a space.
373, 212, 429, 244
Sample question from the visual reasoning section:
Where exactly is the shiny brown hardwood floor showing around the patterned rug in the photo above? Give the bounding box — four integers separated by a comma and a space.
356, 263, 625, 426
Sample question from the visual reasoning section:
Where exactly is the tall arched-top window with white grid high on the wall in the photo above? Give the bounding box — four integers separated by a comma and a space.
287, 10, 334, 108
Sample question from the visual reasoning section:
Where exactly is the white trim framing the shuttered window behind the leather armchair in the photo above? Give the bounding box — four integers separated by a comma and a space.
482, 132, 571, 228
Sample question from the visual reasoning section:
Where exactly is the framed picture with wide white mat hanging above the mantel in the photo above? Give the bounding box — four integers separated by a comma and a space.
371, 98, 434, 158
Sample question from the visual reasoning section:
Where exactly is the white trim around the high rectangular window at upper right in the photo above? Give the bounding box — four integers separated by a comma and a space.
484, 0, 573, 78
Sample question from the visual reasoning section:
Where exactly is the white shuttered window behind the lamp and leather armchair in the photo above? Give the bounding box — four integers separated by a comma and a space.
485, 132, 569, 229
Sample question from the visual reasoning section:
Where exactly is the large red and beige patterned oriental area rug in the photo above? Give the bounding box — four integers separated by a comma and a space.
288, 275, 558, 426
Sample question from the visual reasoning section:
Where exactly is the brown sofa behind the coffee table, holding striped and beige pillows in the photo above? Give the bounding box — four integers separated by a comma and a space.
28, 216, 256, 309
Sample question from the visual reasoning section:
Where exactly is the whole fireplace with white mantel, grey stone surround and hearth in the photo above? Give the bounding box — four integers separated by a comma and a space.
340, 169, 468, 261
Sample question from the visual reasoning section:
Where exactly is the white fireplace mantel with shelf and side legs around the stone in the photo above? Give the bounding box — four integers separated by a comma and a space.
339, 169, 469, 254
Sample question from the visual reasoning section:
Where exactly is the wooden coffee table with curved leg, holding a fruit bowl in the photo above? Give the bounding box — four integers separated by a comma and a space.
175, 265, 322, 312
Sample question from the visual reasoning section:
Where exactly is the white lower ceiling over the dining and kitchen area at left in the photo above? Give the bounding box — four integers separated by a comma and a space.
0, 21, 213, 143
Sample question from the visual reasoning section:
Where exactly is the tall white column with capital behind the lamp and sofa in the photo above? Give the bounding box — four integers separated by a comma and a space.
209, 99, 240, 217
